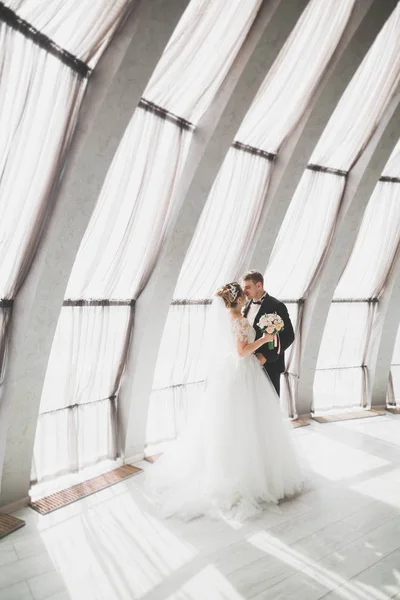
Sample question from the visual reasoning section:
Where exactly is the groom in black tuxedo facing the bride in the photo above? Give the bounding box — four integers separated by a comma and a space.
243, 271, 294, 396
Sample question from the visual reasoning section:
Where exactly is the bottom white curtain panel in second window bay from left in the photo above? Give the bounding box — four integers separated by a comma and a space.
34, 305, 132, 480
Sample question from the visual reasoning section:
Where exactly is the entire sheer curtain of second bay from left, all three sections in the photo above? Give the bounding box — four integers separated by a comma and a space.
35, 0, 262, 479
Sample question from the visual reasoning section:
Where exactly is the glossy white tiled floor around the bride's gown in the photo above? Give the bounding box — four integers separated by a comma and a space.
0, 415, 400, 600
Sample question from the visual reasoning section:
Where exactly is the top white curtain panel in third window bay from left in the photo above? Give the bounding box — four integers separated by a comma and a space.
237, 0, 355, 153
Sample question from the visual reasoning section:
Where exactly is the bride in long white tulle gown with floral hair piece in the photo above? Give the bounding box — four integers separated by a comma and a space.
145, 282, 302, 521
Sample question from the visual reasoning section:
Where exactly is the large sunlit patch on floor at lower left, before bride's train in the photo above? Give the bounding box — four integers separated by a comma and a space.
38, 495, 197, 598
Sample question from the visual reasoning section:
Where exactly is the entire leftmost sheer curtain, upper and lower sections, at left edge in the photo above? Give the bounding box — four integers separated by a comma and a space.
0, 0, 128, 464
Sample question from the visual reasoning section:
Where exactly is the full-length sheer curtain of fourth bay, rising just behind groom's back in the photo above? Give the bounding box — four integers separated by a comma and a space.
265, 5, 400, 414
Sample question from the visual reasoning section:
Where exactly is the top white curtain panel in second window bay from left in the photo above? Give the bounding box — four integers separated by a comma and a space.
144, 0, 262, 123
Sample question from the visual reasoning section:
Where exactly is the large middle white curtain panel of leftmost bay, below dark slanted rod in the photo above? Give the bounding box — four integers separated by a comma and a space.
0, 30, 86, 298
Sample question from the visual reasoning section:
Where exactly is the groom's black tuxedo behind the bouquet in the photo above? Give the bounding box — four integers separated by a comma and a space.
243, 294, 294, 395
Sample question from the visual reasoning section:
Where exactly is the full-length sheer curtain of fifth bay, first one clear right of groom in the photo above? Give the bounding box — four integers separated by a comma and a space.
314, 142, 400, 411
